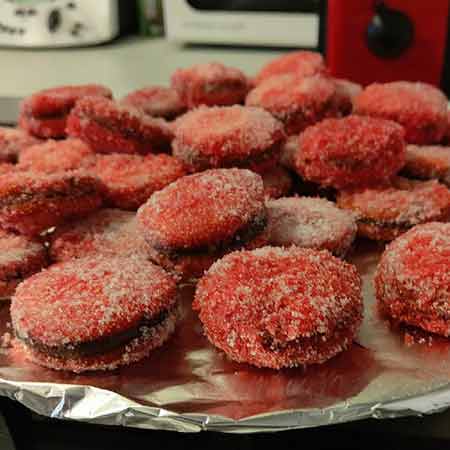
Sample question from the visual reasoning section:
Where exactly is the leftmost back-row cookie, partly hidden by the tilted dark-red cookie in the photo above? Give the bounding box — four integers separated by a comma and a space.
19, 84, 112, 139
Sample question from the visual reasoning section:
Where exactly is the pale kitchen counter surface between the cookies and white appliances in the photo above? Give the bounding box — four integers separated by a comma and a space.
0, 37, 281, 97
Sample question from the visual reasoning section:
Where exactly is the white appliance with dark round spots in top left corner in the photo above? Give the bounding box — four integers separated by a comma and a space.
0, 0, 119, 47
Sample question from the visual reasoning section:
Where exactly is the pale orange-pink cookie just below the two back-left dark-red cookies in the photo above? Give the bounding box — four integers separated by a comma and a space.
18, 139, 94, 174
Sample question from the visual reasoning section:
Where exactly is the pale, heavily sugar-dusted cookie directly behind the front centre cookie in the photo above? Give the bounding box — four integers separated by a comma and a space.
266, 197, 357, 256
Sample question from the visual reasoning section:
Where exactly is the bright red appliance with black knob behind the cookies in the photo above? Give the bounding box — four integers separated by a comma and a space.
325, 0, 449, 85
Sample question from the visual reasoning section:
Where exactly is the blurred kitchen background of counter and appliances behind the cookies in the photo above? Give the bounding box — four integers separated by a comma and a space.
0, 0, 449, 100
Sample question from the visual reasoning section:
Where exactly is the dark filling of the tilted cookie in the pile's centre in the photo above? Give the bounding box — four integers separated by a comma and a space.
150, 212, 267, 260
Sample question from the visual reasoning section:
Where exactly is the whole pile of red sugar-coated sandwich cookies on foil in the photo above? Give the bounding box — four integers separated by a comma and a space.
0, 51, 450, 372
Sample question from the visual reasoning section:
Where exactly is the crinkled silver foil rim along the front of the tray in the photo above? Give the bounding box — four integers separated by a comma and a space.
0, 378, 450, 433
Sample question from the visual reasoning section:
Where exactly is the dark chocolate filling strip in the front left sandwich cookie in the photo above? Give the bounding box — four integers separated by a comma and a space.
16, 309, 171, 359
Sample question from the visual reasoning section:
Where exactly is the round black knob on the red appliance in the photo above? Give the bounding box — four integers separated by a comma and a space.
366, 2, 414, 59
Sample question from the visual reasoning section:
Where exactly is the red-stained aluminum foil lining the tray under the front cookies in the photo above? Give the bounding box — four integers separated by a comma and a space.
0, 243, 450, 433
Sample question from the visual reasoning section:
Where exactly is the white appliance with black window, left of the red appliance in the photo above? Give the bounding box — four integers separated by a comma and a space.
163, 0, 320, 48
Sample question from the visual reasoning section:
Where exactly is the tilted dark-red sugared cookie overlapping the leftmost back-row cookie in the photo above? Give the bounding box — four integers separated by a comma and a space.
67, 97, 173, 154
